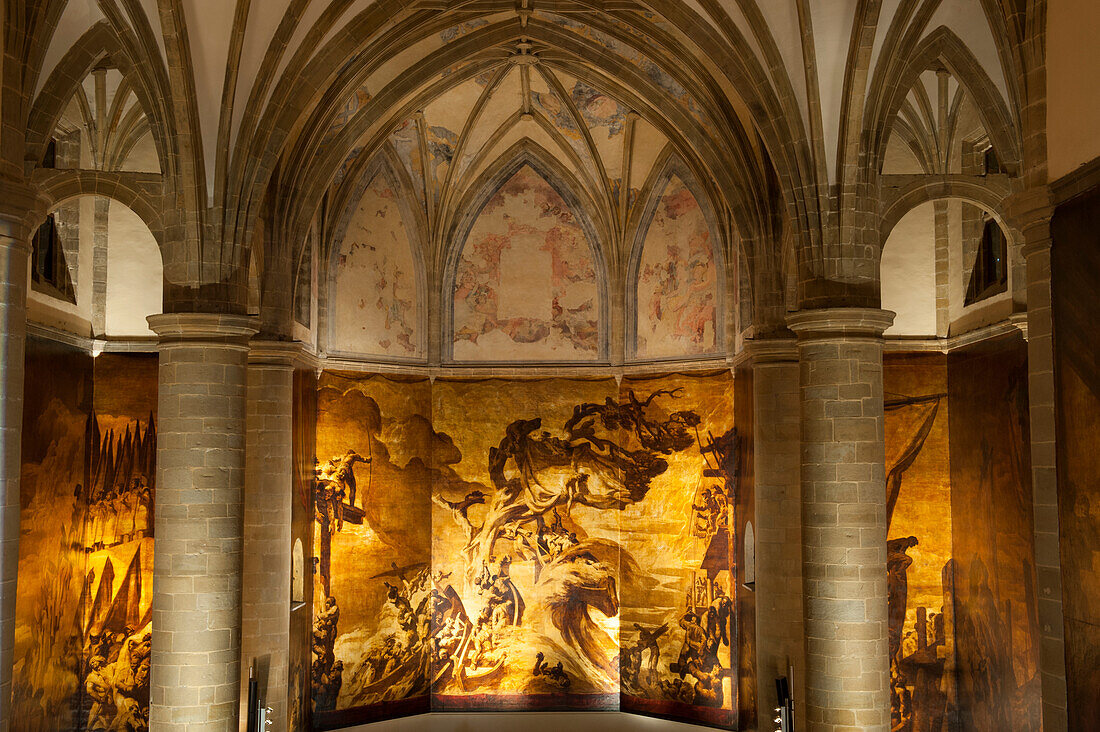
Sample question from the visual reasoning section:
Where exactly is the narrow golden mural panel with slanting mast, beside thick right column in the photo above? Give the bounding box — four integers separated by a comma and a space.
882, 354, 958, 732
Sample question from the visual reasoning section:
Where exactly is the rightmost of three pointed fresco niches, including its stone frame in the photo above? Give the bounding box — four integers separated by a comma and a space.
627, 159, 725, 360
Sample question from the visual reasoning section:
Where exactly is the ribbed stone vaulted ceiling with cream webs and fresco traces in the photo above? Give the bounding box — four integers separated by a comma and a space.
3, 0, 1042, 323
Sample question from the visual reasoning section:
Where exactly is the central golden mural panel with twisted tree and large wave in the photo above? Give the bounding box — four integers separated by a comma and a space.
424, 379, 624, 709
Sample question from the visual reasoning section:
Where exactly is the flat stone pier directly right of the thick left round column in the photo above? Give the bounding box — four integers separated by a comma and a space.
241, 340, 298, 732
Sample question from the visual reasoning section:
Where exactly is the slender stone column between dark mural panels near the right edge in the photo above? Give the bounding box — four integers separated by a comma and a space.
1009, 186, 1069, 732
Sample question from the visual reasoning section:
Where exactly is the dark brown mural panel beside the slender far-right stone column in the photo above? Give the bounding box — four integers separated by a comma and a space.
948, 336, 1041, 732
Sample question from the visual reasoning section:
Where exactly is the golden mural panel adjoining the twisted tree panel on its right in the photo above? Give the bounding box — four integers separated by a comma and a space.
619, 371, 740, 726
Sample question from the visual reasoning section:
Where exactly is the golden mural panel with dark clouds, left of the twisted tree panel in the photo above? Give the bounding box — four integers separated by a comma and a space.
310, 372, 436, 725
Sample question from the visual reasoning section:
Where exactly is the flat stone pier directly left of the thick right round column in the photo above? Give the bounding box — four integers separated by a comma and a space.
746, 338, 805, 729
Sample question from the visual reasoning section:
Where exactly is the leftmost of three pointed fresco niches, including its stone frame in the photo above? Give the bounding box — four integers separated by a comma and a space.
327, 155, 426, 361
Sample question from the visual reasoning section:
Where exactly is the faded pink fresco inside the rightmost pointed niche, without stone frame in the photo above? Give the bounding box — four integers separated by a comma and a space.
637, 176, 718, 358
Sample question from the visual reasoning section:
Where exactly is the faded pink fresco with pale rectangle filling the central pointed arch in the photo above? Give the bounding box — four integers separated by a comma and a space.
453, 165, 600, 361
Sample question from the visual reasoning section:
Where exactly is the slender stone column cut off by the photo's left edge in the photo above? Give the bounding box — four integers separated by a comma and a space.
0, 186, 31, 731
